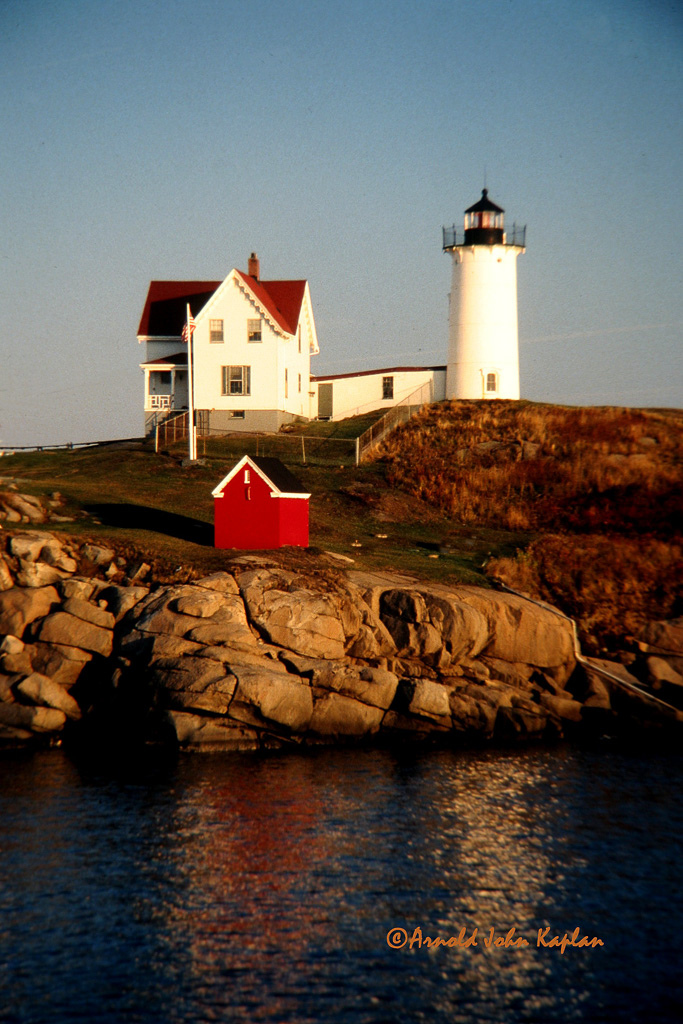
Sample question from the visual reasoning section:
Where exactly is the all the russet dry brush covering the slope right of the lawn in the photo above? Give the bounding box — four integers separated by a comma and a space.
378, 401, 683, 651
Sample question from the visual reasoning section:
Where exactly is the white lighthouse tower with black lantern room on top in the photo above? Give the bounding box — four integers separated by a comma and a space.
443, 188, 526, 398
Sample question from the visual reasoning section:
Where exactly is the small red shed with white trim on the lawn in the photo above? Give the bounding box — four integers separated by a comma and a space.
212, 455, 310, 549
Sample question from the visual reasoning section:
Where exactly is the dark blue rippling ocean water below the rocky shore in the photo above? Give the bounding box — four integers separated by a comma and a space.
0, 744, 683, 1024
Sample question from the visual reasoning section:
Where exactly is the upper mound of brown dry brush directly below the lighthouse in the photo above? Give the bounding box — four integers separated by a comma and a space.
378, 401, 683, 532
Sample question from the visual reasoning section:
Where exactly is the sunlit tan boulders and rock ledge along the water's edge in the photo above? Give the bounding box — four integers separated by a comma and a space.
0, 520, 683, 751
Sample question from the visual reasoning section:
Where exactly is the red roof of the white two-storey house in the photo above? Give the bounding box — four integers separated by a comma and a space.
137, 270, 306, 338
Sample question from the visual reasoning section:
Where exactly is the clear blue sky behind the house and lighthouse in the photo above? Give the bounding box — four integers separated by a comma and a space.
0, 0, 683, 445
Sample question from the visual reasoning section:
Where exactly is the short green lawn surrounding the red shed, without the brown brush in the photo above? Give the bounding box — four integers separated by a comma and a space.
0, 434, 515, 586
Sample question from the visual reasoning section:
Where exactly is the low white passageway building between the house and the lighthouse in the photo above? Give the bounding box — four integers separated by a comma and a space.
310, 366, 445, 420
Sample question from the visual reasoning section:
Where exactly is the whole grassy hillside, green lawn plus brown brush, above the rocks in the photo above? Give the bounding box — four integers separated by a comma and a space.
0, 401, 683, 651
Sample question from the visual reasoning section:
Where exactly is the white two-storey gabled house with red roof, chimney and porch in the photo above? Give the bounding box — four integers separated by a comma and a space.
137, 253, 318, 433
